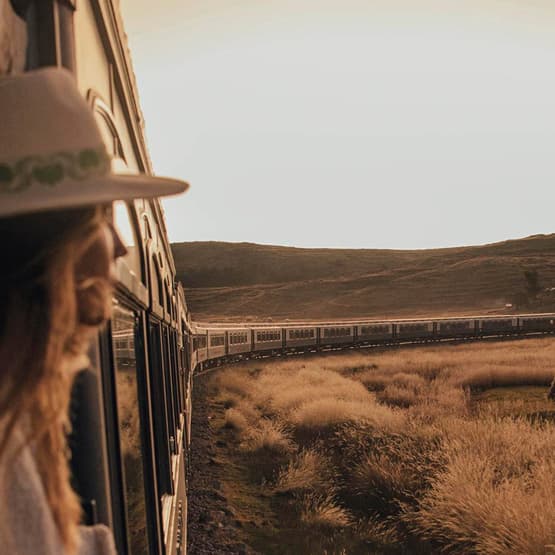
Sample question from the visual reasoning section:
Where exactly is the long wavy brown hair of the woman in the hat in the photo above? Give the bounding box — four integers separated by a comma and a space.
0, 207, 111, 553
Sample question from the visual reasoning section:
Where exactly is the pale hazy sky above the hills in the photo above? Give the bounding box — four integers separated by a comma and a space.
122, 0, 555, 248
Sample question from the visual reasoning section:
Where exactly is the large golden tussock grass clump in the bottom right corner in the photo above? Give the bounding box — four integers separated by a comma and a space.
406, 453, 555, 555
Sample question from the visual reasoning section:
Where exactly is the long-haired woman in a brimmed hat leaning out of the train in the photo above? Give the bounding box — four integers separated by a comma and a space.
0, 68, 187, 555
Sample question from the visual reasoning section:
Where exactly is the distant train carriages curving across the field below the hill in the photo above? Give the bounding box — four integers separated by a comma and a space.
192, 313, 555, 367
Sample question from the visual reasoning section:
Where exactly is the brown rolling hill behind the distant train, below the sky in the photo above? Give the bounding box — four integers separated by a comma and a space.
172, 234, 555, 321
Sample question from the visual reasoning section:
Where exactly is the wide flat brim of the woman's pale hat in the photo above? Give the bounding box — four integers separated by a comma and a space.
0, 173, 189, 217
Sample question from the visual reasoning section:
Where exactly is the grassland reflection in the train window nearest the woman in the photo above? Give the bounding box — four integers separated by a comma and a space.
112, 306, 148, 554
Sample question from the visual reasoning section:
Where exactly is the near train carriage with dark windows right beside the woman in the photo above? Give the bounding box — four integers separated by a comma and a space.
0, 0, 192, 554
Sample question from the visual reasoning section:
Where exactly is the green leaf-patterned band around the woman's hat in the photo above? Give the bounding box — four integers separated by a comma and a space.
0, 146, 110, 194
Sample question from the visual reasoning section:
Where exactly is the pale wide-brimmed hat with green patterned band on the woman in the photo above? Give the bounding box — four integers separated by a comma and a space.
0, 68, 189, 217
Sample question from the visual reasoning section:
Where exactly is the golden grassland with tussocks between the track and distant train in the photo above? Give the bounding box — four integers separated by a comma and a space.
207, 338, 555, 555
